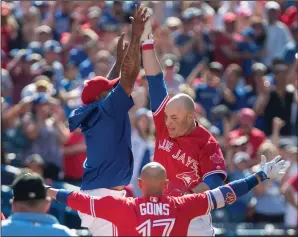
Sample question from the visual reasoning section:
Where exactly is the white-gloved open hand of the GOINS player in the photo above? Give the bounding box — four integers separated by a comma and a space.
260, 155, 287, 179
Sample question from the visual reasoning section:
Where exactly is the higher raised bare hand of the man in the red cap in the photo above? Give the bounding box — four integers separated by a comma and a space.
130, 4, 149, 37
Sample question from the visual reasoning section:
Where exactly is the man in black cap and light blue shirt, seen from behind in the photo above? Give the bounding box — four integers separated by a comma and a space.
1, 174, 76, 236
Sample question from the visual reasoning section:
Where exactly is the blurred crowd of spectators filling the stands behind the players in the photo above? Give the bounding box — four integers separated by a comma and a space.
1, 0, 298, 235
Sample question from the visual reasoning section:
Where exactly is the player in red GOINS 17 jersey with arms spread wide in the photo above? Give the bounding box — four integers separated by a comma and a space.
48, 157, 286, 236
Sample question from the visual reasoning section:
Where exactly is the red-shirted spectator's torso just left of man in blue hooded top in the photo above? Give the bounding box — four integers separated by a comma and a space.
63, 129, 86, 181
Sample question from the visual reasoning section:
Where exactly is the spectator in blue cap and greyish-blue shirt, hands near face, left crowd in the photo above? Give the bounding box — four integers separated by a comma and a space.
22, 93, 68, 180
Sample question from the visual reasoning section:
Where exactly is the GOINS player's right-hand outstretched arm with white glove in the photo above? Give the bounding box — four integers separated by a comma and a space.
182, 156, 286, 218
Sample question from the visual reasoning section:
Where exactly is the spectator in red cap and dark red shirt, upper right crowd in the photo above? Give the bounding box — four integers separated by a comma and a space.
214, 12, 242, 68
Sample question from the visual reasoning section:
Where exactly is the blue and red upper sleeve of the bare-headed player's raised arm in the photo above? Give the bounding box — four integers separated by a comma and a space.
146, 73, 169, 133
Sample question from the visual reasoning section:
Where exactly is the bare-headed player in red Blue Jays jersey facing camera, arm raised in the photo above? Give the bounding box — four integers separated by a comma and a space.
142, 16, 226, 236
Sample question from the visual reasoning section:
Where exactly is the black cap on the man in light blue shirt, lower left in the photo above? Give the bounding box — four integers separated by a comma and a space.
12, 174, 46, 201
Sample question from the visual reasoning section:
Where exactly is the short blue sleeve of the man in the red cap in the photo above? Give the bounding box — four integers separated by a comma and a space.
100, 84, 134, 118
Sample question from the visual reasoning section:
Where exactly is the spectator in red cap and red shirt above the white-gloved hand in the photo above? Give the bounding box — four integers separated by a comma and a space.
228, 108, 266, 166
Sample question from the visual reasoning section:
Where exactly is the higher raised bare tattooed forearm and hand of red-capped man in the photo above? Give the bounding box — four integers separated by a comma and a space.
120, 5, 149, 96
